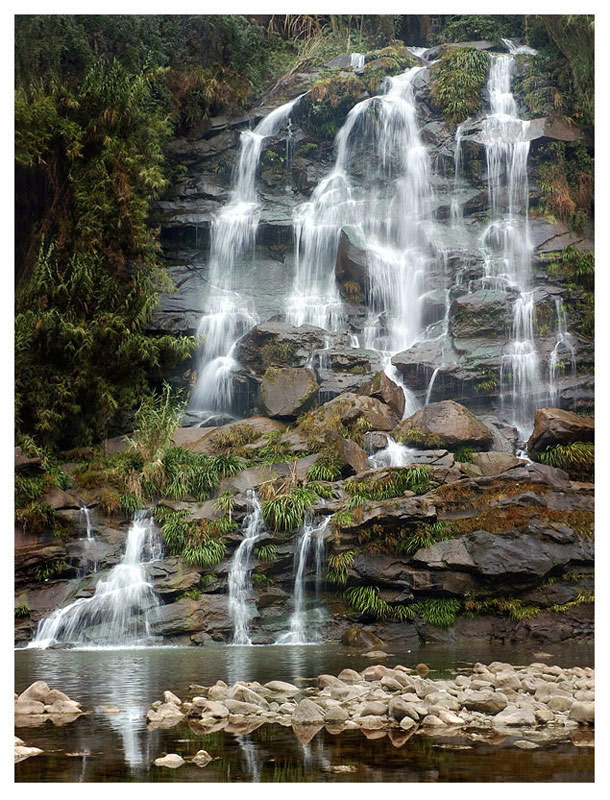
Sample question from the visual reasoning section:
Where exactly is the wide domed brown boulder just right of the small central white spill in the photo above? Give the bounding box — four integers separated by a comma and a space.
392, 400, 493, 450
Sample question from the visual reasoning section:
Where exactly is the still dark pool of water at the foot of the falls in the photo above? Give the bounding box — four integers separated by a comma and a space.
15, 642, 593, 782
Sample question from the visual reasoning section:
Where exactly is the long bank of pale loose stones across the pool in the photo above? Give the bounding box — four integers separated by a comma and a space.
147, 653, 595, 749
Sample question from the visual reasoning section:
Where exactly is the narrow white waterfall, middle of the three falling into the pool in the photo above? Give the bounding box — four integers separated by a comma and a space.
228, 489, 265, 644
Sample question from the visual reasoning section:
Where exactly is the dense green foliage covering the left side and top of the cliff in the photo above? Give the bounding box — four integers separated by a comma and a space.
15, 14, 593, 449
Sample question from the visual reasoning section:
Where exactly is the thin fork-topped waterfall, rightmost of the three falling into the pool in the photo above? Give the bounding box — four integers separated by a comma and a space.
277, 517, 330, 644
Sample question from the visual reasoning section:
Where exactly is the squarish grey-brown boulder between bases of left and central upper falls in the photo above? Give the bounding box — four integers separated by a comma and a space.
260, 367, 320, 418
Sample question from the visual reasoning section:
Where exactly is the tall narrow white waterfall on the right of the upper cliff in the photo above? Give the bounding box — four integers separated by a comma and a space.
482, 55, 541, 439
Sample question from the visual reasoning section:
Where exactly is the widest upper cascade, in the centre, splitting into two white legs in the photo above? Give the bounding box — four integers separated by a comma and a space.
287, 67, 438, 414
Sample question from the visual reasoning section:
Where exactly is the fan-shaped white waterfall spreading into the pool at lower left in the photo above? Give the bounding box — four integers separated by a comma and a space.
28, 511, 162, 649
